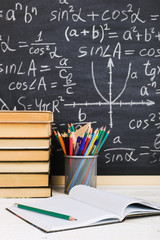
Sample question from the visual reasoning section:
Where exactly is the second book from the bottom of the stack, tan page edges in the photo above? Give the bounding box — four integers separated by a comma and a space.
0, 173, 49, 187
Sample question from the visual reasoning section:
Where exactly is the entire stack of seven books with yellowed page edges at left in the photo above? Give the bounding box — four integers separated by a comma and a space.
0, 111, 53, 197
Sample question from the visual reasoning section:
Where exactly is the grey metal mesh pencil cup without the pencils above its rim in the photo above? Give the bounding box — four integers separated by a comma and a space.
65, 155, 98, 193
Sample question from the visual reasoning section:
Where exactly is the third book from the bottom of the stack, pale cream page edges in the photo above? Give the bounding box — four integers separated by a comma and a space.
0, 161, 50, 173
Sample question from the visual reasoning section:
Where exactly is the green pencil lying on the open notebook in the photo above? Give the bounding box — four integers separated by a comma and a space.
15, 203, 76, 221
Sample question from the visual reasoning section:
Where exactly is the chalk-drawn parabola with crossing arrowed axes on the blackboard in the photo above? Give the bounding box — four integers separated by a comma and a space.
64, 58, 155, 128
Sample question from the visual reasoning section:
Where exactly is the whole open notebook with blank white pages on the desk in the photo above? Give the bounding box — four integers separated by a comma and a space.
7, 185, 160, 232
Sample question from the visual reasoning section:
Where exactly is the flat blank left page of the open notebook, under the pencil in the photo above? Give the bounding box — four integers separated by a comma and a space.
8, 196, 116, 231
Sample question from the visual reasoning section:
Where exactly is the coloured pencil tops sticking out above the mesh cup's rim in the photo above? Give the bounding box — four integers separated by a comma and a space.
54, 123, 110, 156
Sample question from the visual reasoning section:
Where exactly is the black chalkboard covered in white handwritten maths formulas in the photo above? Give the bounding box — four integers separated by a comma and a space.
0, 0, 160, 175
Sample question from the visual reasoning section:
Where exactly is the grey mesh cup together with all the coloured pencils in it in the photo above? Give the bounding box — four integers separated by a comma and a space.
54, 123, 110, 193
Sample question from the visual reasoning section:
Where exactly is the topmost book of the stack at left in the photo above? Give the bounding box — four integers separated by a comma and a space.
0, 111, 53, 123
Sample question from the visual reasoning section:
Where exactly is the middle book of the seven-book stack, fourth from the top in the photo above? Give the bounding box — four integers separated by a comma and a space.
0, 149, 51, 162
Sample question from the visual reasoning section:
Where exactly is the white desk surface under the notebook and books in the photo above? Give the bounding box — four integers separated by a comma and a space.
0, 186, 160, 240
